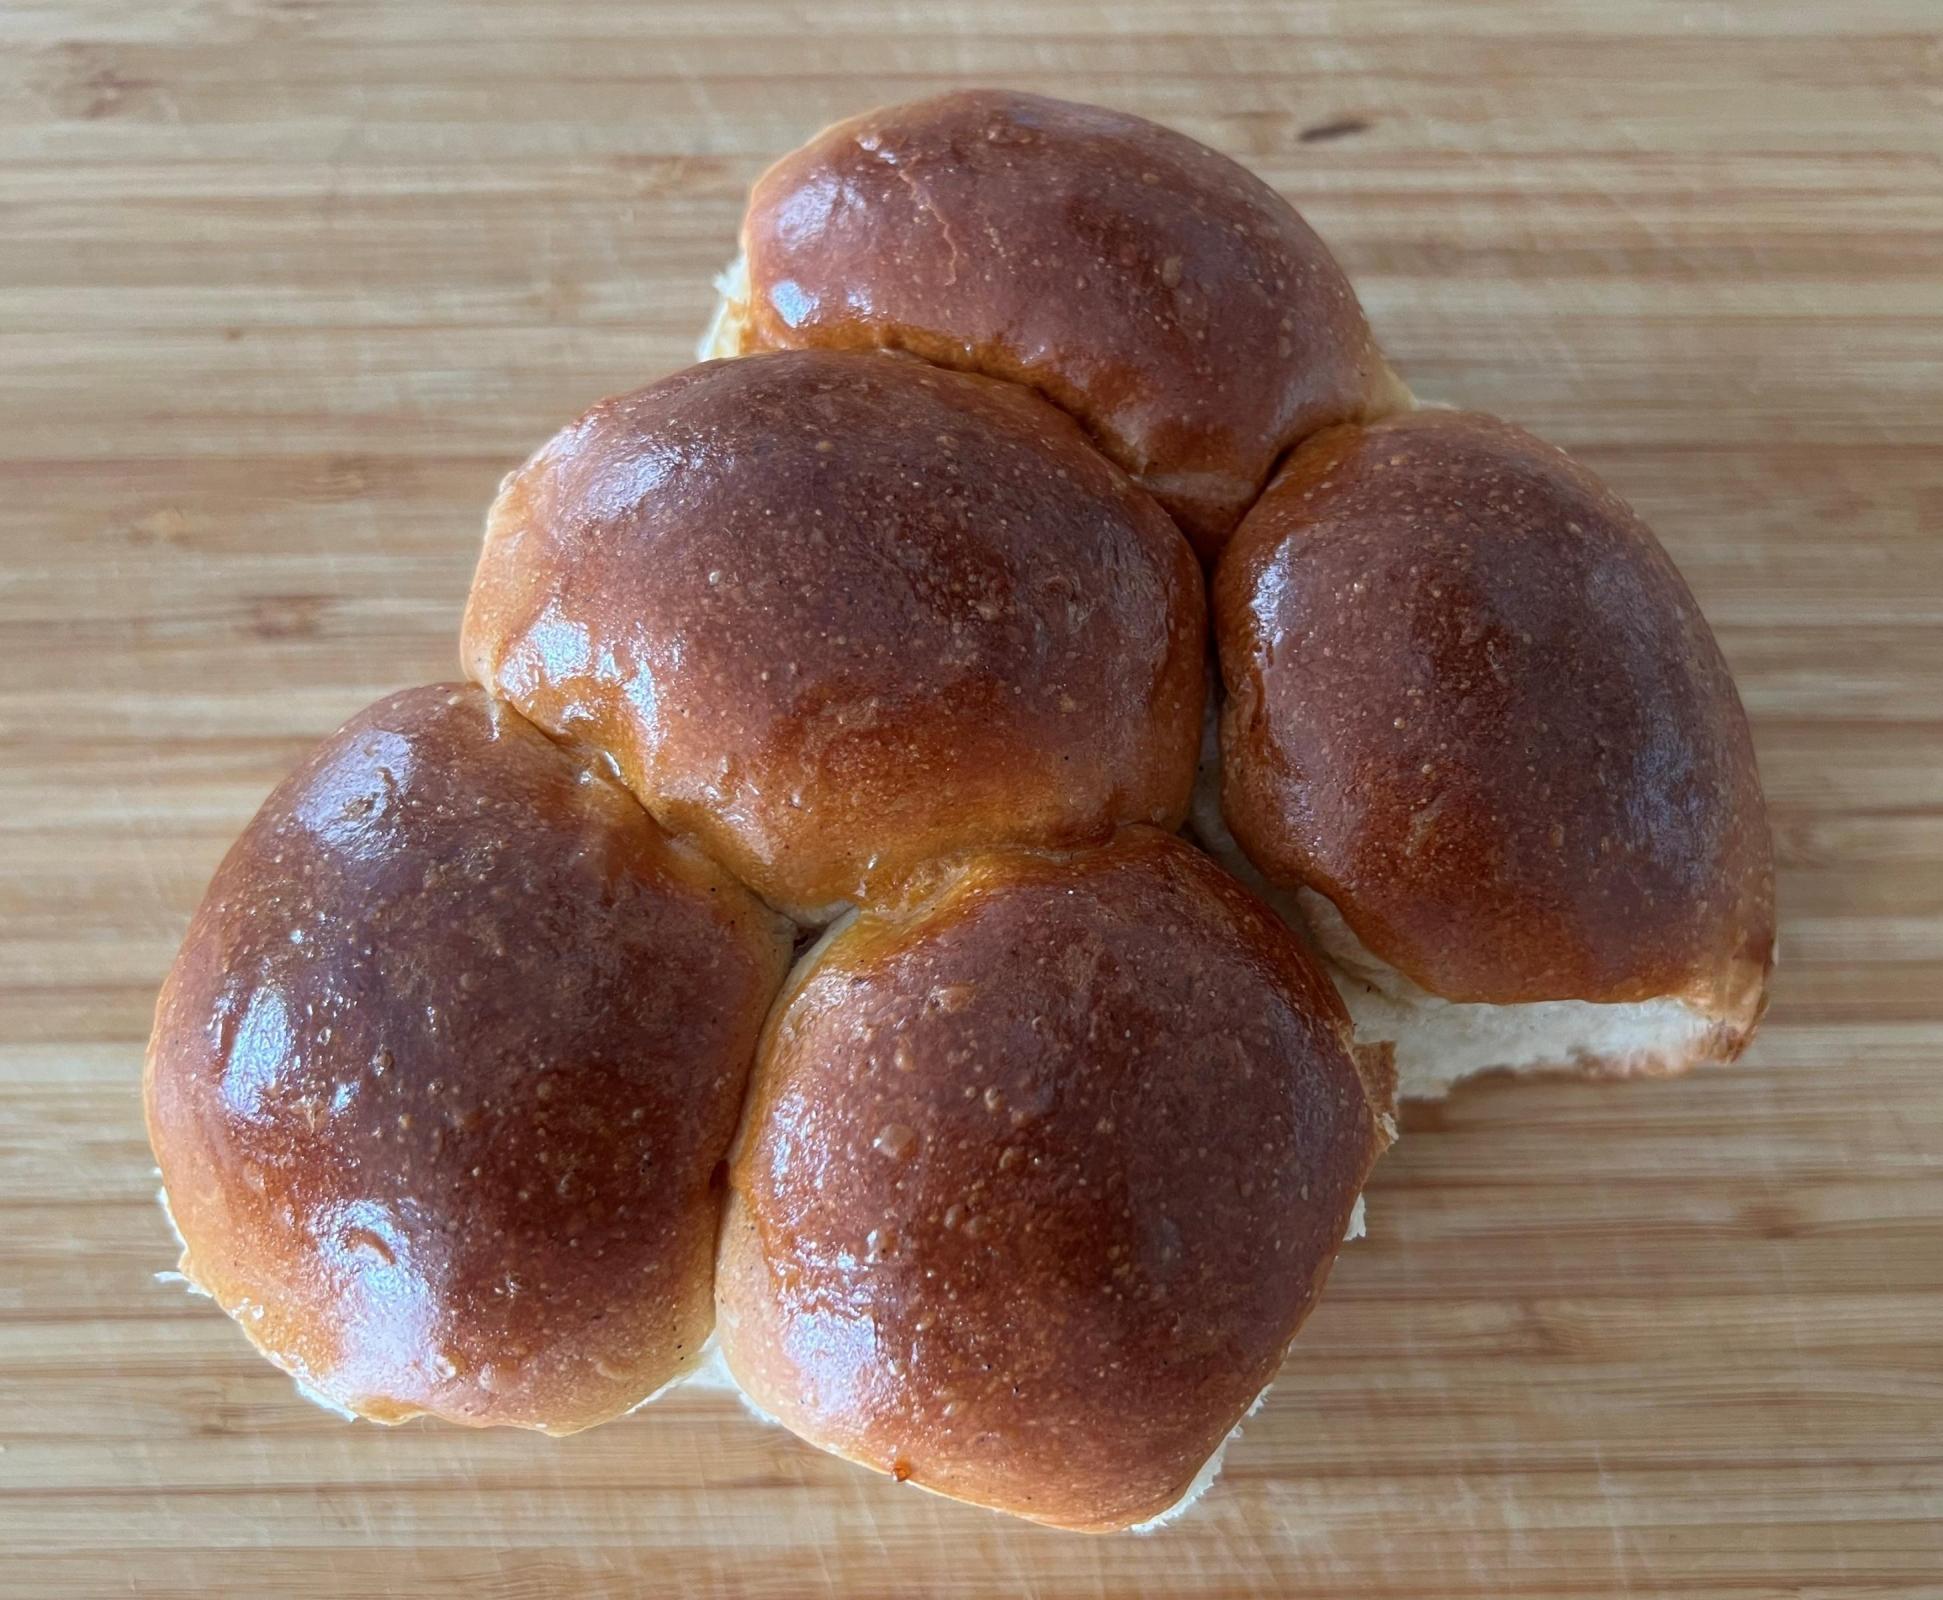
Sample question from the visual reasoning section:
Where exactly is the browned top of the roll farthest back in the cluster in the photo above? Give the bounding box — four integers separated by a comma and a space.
722, 89, 1401, 560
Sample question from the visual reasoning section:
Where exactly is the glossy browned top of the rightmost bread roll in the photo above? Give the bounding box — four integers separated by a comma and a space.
1214, 412, 1774, 1021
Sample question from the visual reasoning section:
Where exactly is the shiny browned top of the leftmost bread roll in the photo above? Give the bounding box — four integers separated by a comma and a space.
146, 686, 789, 1433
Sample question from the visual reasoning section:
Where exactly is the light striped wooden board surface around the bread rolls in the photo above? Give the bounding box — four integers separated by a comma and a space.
0, 0, 1943, 1600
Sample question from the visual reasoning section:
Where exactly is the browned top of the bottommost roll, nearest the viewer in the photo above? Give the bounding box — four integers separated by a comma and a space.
717, 828, 1381, 1530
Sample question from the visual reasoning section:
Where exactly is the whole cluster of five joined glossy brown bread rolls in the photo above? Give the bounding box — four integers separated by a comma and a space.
146, 91, 1774, 1530
